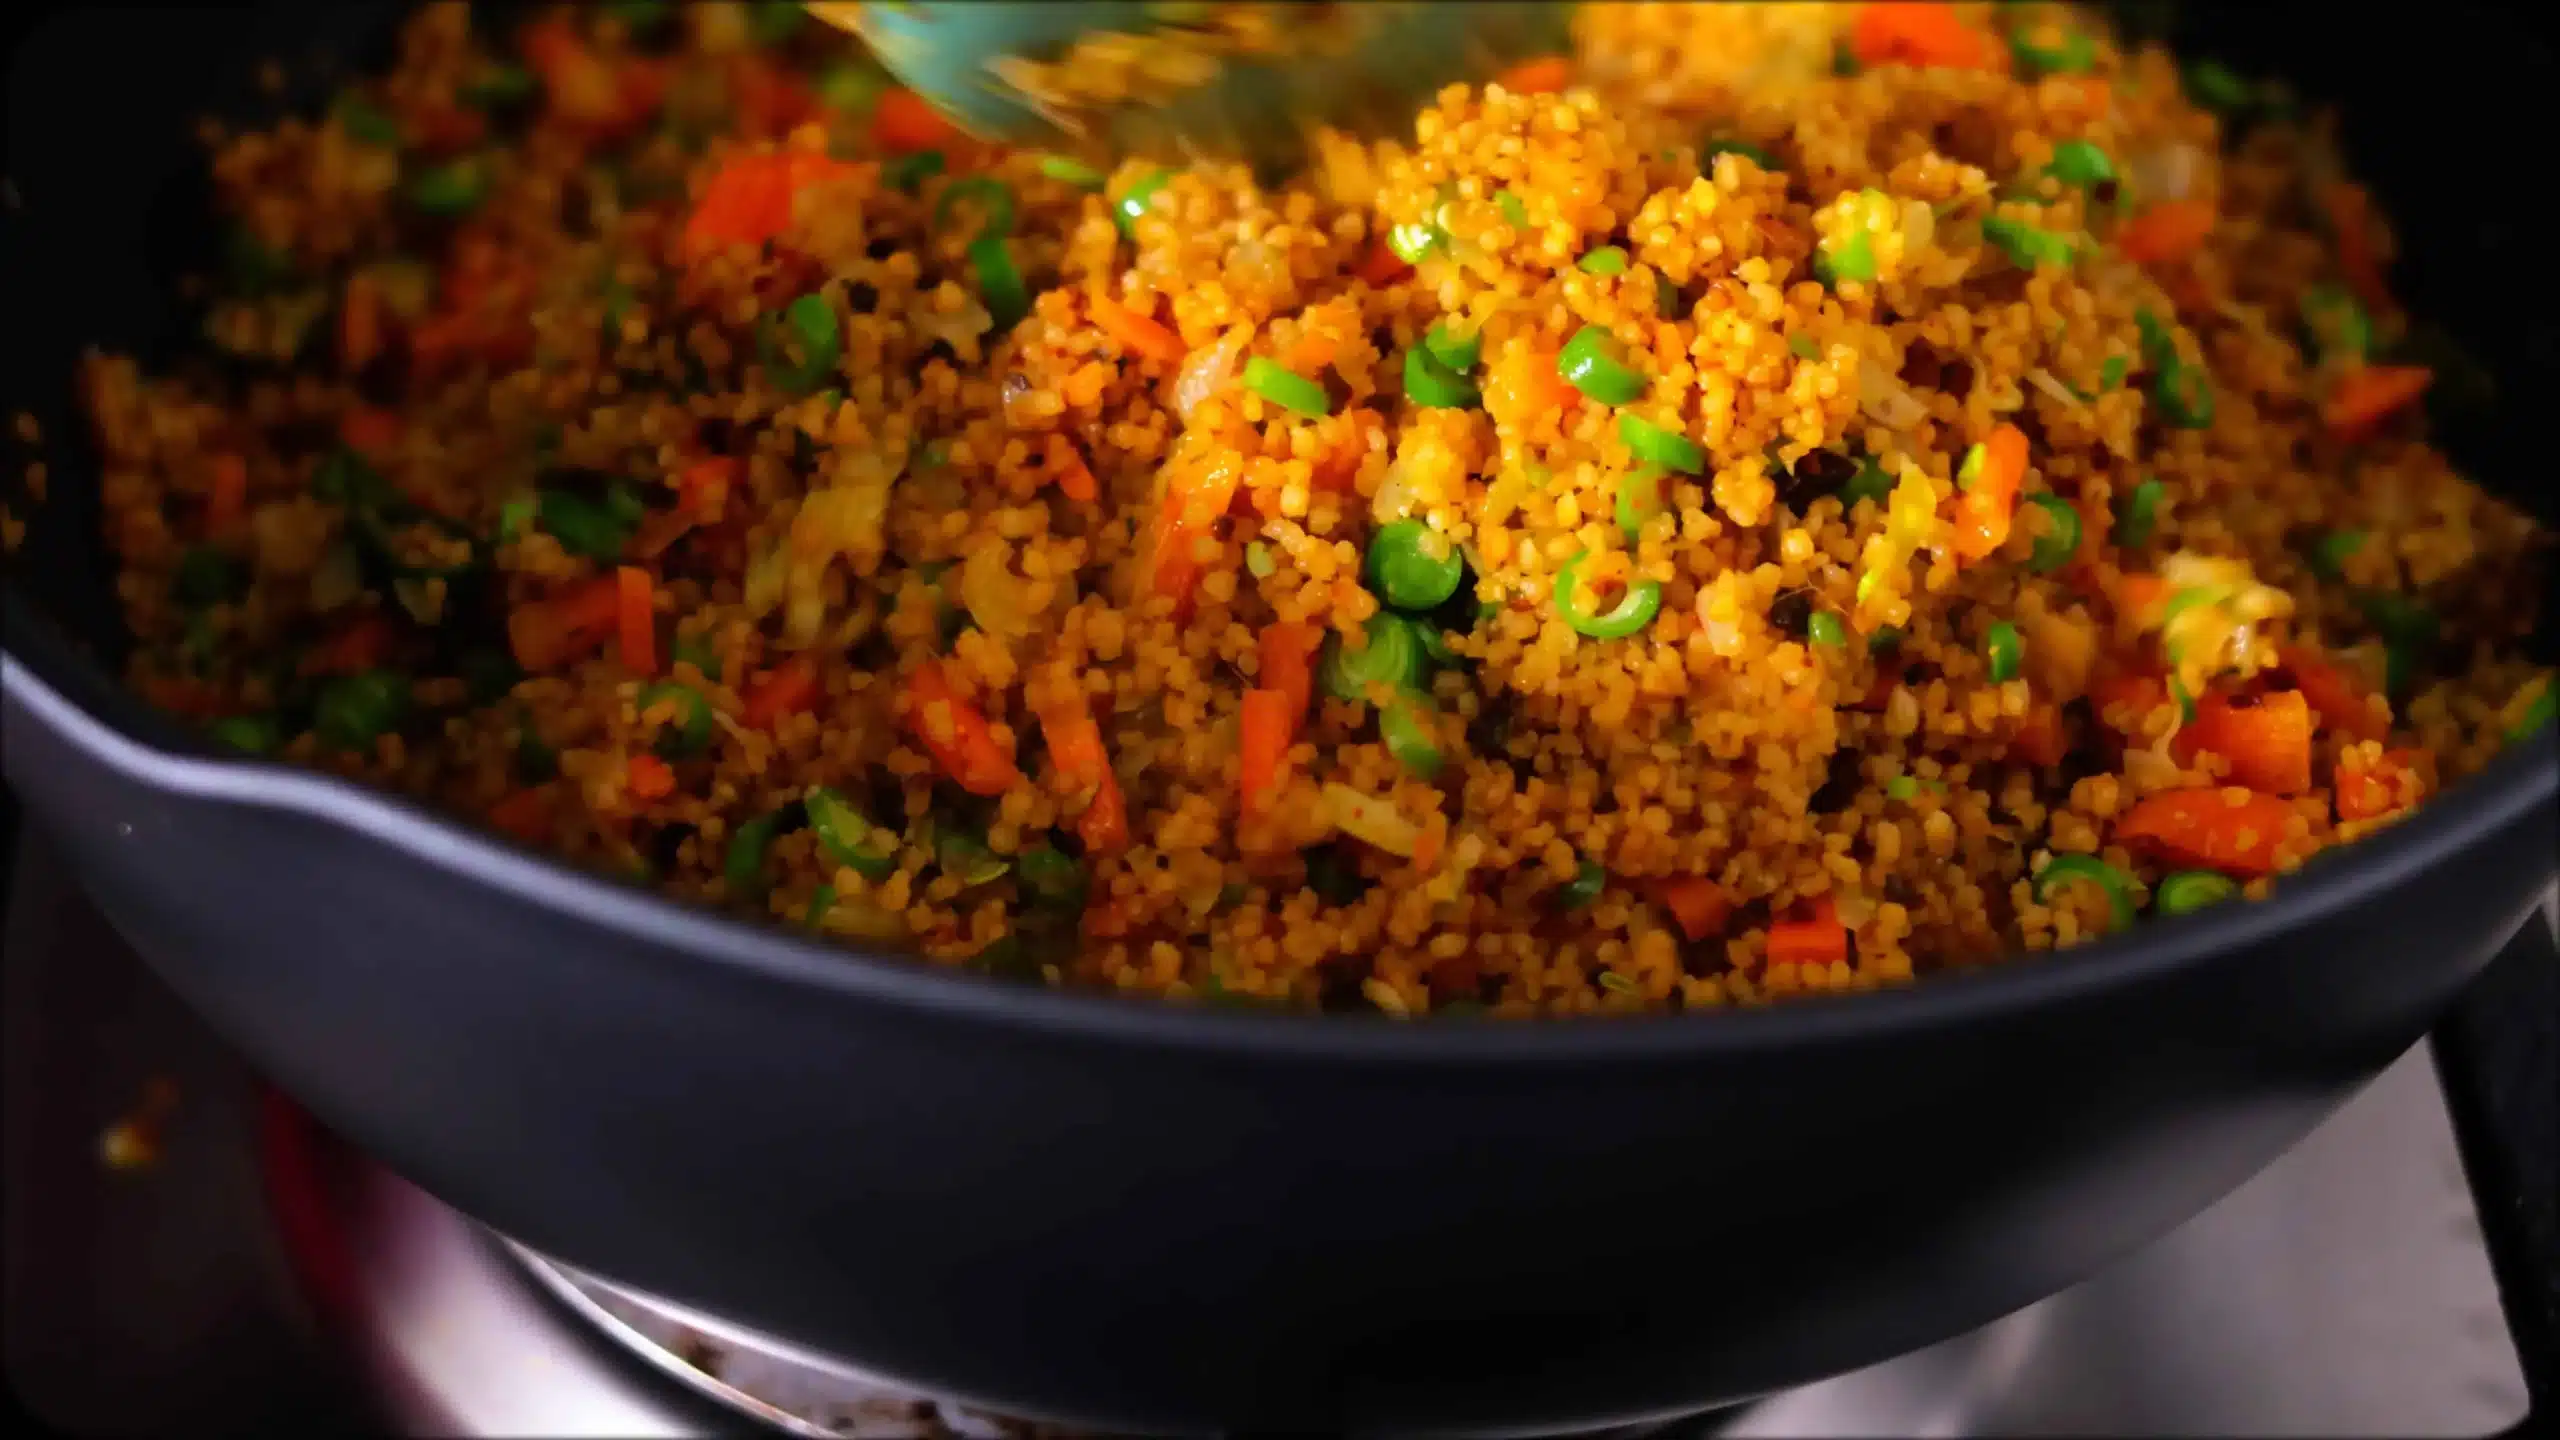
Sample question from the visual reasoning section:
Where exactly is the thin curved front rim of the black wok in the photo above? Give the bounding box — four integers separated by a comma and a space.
0, 577, 2560, 1071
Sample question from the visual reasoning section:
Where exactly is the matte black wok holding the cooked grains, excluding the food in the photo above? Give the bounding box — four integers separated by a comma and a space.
0, 8, 2560, 1430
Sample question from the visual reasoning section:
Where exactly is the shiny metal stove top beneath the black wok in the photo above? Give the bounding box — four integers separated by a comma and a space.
0, 840, 2527, 1440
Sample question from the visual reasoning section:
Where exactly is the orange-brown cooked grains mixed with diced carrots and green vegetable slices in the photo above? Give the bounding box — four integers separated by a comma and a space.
55, 3, 2555, 1015
